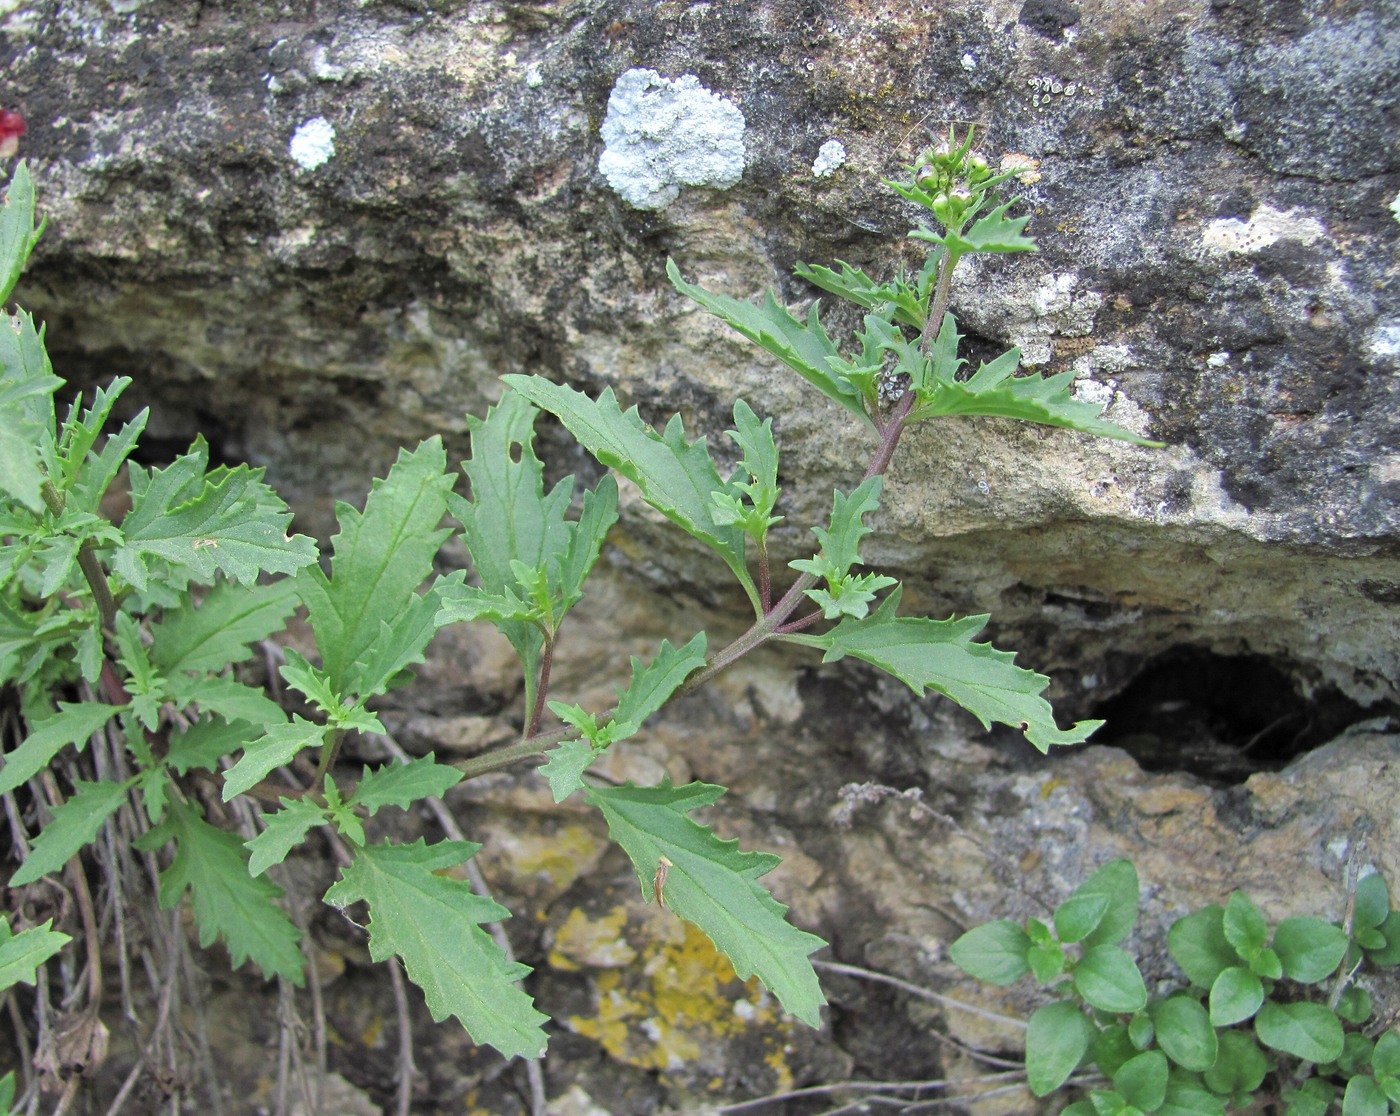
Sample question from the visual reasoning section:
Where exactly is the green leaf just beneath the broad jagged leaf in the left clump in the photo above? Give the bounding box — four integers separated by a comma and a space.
151, 580, 298, 674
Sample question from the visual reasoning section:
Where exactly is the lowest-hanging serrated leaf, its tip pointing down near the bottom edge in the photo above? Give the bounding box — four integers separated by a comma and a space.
325, 840, 549, 1059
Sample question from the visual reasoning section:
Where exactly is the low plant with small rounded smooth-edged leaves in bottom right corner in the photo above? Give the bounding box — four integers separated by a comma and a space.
949, 860, 1400, 1116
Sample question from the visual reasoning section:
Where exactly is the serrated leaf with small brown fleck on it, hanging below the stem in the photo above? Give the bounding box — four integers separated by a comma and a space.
588, 780, 826, 1026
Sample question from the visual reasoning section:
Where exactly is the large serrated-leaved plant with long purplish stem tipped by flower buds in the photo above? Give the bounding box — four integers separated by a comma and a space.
0, 134, 1154, 1097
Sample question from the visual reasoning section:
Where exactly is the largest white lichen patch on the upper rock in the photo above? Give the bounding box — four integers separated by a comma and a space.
598, 70, 748, 210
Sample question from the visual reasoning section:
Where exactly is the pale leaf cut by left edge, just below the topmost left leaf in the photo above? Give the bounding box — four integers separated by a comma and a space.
0, 309, 63, 514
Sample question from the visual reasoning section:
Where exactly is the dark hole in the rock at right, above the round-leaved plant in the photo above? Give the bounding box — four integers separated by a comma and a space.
1092, 647, 1373, 786
